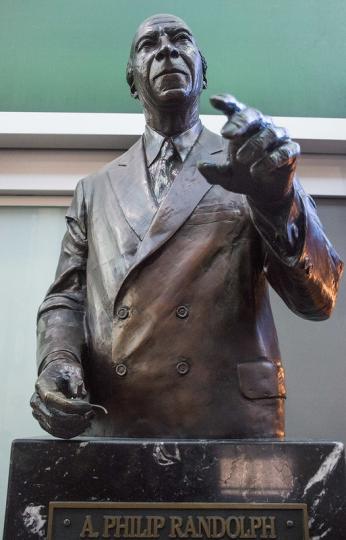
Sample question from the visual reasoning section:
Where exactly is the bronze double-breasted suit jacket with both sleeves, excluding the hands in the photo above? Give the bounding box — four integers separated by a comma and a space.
38, 125, 342, 437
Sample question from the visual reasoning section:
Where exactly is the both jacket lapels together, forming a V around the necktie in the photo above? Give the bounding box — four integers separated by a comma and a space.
108, 128, 224, 301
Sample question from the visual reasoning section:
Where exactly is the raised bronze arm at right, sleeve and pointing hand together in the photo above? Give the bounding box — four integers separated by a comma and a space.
198, 94, 343, 320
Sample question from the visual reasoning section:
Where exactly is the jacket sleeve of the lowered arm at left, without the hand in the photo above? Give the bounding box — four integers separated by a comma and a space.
37, 181, 88, 372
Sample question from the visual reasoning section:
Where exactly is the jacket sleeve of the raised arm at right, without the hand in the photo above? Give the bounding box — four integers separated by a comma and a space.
249, 180, 343, 320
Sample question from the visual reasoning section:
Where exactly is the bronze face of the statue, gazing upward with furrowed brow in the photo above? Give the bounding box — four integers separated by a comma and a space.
131, 15, 203, 109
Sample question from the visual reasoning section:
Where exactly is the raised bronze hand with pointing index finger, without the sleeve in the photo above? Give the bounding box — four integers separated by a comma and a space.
198, 94, 300, 207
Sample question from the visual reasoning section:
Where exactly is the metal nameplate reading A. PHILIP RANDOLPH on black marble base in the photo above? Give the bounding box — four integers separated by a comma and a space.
47, 502, 309, 540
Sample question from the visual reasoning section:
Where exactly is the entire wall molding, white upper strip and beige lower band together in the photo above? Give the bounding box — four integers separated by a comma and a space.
0, 112, 346, 206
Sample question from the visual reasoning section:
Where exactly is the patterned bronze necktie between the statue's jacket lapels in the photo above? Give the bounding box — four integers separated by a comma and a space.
153, 139, 182, 204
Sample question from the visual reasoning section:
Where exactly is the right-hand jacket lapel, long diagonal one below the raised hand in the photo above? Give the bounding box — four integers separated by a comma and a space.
133, 128, 223, 267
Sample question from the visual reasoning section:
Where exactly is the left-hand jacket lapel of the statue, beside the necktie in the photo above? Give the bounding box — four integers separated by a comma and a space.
108, 138, 157, 240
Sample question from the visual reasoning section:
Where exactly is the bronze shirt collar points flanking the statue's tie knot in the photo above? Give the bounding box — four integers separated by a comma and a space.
144, 120, 203, 167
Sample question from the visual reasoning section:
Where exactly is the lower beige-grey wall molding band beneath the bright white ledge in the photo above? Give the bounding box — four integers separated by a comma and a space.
0, 149, 346, 202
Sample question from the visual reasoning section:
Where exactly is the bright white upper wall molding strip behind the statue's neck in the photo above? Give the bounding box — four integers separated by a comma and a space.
0, 112, 346, 154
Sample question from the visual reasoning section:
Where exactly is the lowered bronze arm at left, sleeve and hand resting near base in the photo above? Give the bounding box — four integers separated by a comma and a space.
31, 182, 93, 438
